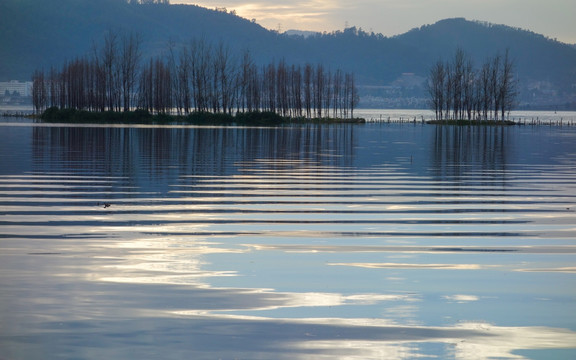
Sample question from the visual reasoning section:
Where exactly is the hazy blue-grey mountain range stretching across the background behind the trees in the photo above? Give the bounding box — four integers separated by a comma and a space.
0, 0, 576, 108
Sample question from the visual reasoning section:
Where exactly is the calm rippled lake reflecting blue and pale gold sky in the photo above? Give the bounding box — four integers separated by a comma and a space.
0, 118, 576, 360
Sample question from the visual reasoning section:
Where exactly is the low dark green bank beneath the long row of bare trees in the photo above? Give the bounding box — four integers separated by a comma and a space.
40, 107, 365, 125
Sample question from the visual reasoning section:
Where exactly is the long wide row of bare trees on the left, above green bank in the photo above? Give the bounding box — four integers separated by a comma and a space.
32, 32, 358, 118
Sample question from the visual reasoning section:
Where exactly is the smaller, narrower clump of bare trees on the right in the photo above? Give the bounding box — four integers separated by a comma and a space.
427, 49, 517, 121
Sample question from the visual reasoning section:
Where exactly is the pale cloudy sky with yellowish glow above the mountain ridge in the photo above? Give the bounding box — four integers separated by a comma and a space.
170, 0, 576, 43
